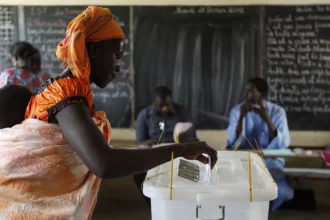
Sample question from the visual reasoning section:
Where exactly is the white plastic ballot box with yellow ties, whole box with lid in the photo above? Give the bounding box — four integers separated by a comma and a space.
143, 151, 277, 220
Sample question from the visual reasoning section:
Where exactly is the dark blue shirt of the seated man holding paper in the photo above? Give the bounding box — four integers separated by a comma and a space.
136, 104, 197, 143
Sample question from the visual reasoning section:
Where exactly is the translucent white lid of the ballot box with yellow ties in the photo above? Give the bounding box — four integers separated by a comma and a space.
143, 151, 277, 202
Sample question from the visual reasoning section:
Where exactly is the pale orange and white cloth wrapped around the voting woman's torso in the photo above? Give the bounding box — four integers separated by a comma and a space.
0, 117, 110, 220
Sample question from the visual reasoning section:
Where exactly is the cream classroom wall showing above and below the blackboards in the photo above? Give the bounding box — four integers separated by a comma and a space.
0, 0, 330, 150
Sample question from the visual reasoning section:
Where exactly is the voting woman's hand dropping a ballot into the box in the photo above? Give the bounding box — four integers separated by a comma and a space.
180, 141, 218, 169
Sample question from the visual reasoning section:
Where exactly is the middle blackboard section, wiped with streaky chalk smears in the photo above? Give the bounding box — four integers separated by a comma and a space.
134, 6, 260, 129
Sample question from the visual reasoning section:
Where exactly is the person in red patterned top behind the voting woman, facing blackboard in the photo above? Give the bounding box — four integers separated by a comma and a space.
0, 41, 50, 91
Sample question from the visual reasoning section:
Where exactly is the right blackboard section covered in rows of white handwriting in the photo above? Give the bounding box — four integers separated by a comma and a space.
265, 6, 330, 130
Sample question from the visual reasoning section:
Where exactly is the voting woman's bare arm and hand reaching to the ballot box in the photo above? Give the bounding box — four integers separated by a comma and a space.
56, 104, 217, 178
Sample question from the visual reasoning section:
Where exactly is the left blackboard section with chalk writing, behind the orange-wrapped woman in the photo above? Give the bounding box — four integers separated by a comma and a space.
0, 6, 132, 127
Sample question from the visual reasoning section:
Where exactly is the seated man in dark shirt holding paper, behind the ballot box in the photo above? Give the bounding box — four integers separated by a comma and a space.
134, 86, 198, 205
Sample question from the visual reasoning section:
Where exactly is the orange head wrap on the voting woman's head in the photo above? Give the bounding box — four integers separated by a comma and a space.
55, 6, 125, 80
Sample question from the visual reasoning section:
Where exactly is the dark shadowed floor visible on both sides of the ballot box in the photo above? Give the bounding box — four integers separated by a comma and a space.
93, 177, 330, 220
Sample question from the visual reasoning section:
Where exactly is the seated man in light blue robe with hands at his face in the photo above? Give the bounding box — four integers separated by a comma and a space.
226, 77, 294, 211
